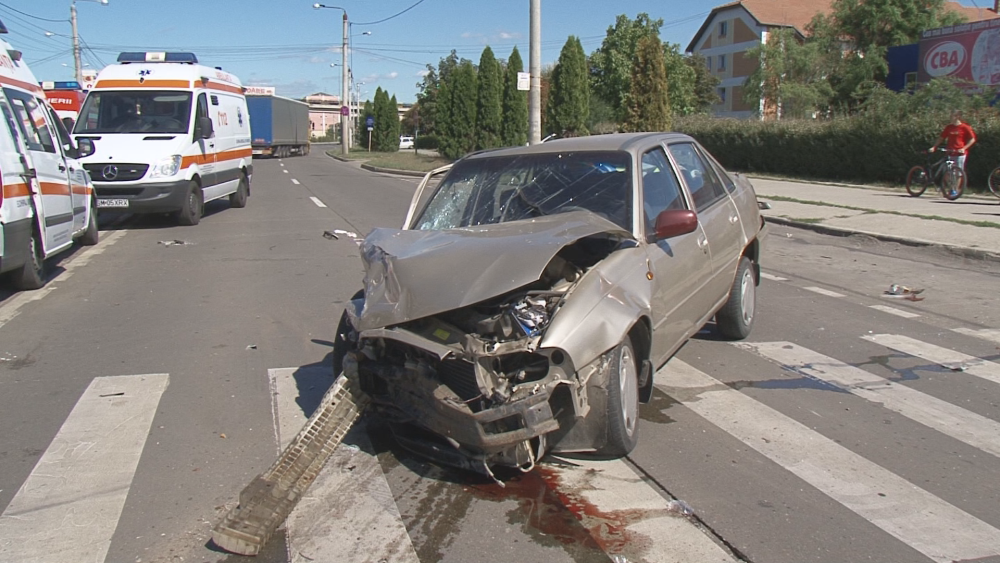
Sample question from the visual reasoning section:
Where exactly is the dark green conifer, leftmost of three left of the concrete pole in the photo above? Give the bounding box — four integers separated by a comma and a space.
438, 59, 476, 159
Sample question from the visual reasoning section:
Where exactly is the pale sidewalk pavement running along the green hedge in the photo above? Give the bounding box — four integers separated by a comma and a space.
750, 176, 1000, 261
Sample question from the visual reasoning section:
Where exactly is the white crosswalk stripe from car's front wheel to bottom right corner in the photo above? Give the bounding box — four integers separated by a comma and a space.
655, 358, 1000, 563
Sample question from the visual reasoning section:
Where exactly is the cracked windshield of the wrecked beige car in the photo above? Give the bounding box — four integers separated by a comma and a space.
414, 151, 632, 230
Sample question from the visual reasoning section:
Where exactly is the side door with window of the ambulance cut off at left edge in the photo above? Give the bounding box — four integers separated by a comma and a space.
4, 88, 73, 255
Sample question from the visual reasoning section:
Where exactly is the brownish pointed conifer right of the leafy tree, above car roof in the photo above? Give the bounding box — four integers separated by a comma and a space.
622, 35, 671, 131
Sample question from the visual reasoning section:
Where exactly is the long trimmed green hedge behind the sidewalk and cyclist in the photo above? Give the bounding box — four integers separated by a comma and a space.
674, 111, 1000, 191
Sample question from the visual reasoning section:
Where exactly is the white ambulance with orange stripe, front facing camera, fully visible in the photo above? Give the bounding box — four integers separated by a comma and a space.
73, 53, 253, 225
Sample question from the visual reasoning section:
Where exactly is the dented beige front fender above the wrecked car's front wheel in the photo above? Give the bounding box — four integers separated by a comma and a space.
539, 246, 653, 368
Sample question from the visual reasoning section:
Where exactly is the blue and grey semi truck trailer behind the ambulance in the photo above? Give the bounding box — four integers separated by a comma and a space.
247, 90, 310, 158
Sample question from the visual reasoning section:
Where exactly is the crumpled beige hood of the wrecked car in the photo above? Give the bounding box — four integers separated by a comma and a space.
355, 211, 632, 330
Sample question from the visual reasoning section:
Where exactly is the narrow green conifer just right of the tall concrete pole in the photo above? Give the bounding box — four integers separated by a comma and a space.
546, 35, 590, 137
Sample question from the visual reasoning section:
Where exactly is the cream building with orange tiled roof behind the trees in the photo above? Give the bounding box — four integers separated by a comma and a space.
687, 0, 1000, 118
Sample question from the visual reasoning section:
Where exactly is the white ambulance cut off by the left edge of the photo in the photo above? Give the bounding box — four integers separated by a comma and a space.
0, 22, 98, 289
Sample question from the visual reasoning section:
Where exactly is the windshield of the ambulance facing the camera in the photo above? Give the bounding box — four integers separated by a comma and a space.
73, 90, 191, 134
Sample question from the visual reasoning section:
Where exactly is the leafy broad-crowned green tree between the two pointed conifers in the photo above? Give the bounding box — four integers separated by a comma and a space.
590, 13, 663, 122
